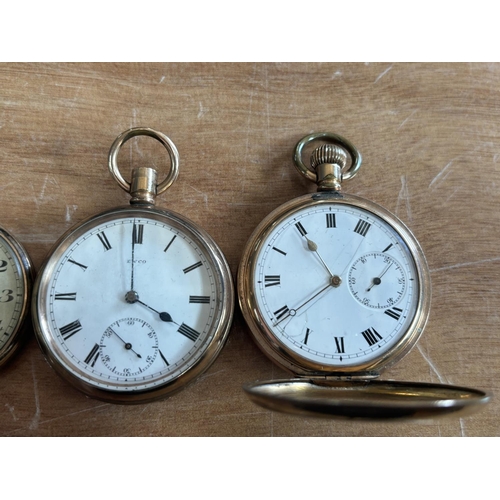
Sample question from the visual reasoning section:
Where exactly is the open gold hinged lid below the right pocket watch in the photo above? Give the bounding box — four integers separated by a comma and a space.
244, 378, 491, 421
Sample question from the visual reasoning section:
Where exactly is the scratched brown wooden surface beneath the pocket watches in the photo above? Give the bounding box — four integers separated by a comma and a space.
0, 63, 500, 436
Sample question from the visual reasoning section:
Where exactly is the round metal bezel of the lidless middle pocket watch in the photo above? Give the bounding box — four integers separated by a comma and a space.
32, 206, 235, 404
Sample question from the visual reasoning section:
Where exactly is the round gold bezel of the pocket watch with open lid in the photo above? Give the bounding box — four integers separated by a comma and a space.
237, 192, 431, 376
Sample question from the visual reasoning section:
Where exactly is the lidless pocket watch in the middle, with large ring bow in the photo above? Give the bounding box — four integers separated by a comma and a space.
32, 128, 235, 403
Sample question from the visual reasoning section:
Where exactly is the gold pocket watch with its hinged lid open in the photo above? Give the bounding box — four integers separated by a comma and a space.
238, 133, 489, 419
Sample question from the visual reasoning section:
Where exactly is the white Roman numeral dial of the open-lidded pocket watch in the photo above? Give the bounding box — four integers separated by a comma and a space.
254, 203, 418, 371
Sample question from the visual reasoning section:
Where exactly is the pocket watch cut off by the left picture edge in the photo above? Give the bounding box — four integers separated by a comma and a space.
0, 227, 33, 366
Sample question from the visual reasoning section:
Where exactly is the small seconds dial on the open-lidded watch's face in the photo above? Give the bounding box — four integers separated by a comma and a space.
348, 250, 406, 308
